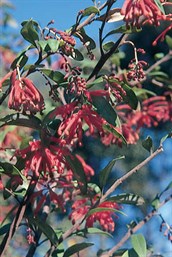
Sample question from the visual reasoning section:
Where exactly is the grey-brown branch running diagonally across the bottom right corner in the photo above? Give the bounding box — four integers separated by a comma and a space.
101, 195, 172, 257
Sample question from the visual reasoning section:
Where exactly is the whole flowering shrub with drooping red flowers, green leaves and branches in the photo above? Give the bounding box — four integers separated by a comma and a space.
0, 0, 172, 257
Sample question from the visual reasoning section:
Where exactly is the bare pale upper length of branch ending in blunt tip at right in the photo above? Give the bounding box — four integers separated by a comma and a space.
100, 146, 163, 203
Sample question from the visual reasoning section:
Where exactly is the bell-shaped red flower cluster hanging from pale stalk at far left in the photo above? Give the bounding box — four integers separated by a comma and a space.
8, 70, 44, 114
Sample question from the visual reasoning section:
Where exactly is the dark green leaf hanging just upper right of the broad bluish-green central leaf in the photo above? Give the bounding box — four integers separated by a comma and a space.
121, 83, 138, 110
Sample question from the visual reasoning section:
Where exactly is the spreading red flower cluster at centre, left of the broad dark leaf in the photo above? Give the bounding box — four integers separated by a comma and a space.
51, 102, 107, 145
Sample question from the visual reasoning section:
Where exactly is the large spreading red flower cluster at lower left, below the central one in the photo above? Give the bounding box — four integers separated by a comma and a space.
15, 137, 68, 178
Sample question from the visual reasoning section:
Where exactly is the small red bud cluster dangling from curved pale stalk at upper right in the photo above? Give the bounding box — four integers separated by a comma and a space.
127, 58, 147, 81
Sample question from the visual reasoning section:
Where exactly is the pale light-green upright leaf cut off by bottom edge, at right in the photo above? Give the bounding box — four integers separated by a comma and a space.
131, 234, 147, 257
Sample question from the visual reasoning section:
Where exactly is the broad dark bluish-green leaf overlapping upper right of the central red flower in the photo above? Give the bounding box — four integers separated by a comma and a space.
91, 96, 117, 126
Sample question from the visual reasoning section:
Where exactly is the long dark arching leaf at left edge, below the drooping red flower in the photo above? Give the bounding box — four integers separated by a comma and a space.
0, 113, 41, 130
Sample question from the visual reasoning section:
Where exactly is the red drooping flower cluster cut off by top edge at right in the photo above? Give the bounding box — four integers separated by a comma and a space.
121, 0, 166, 28
